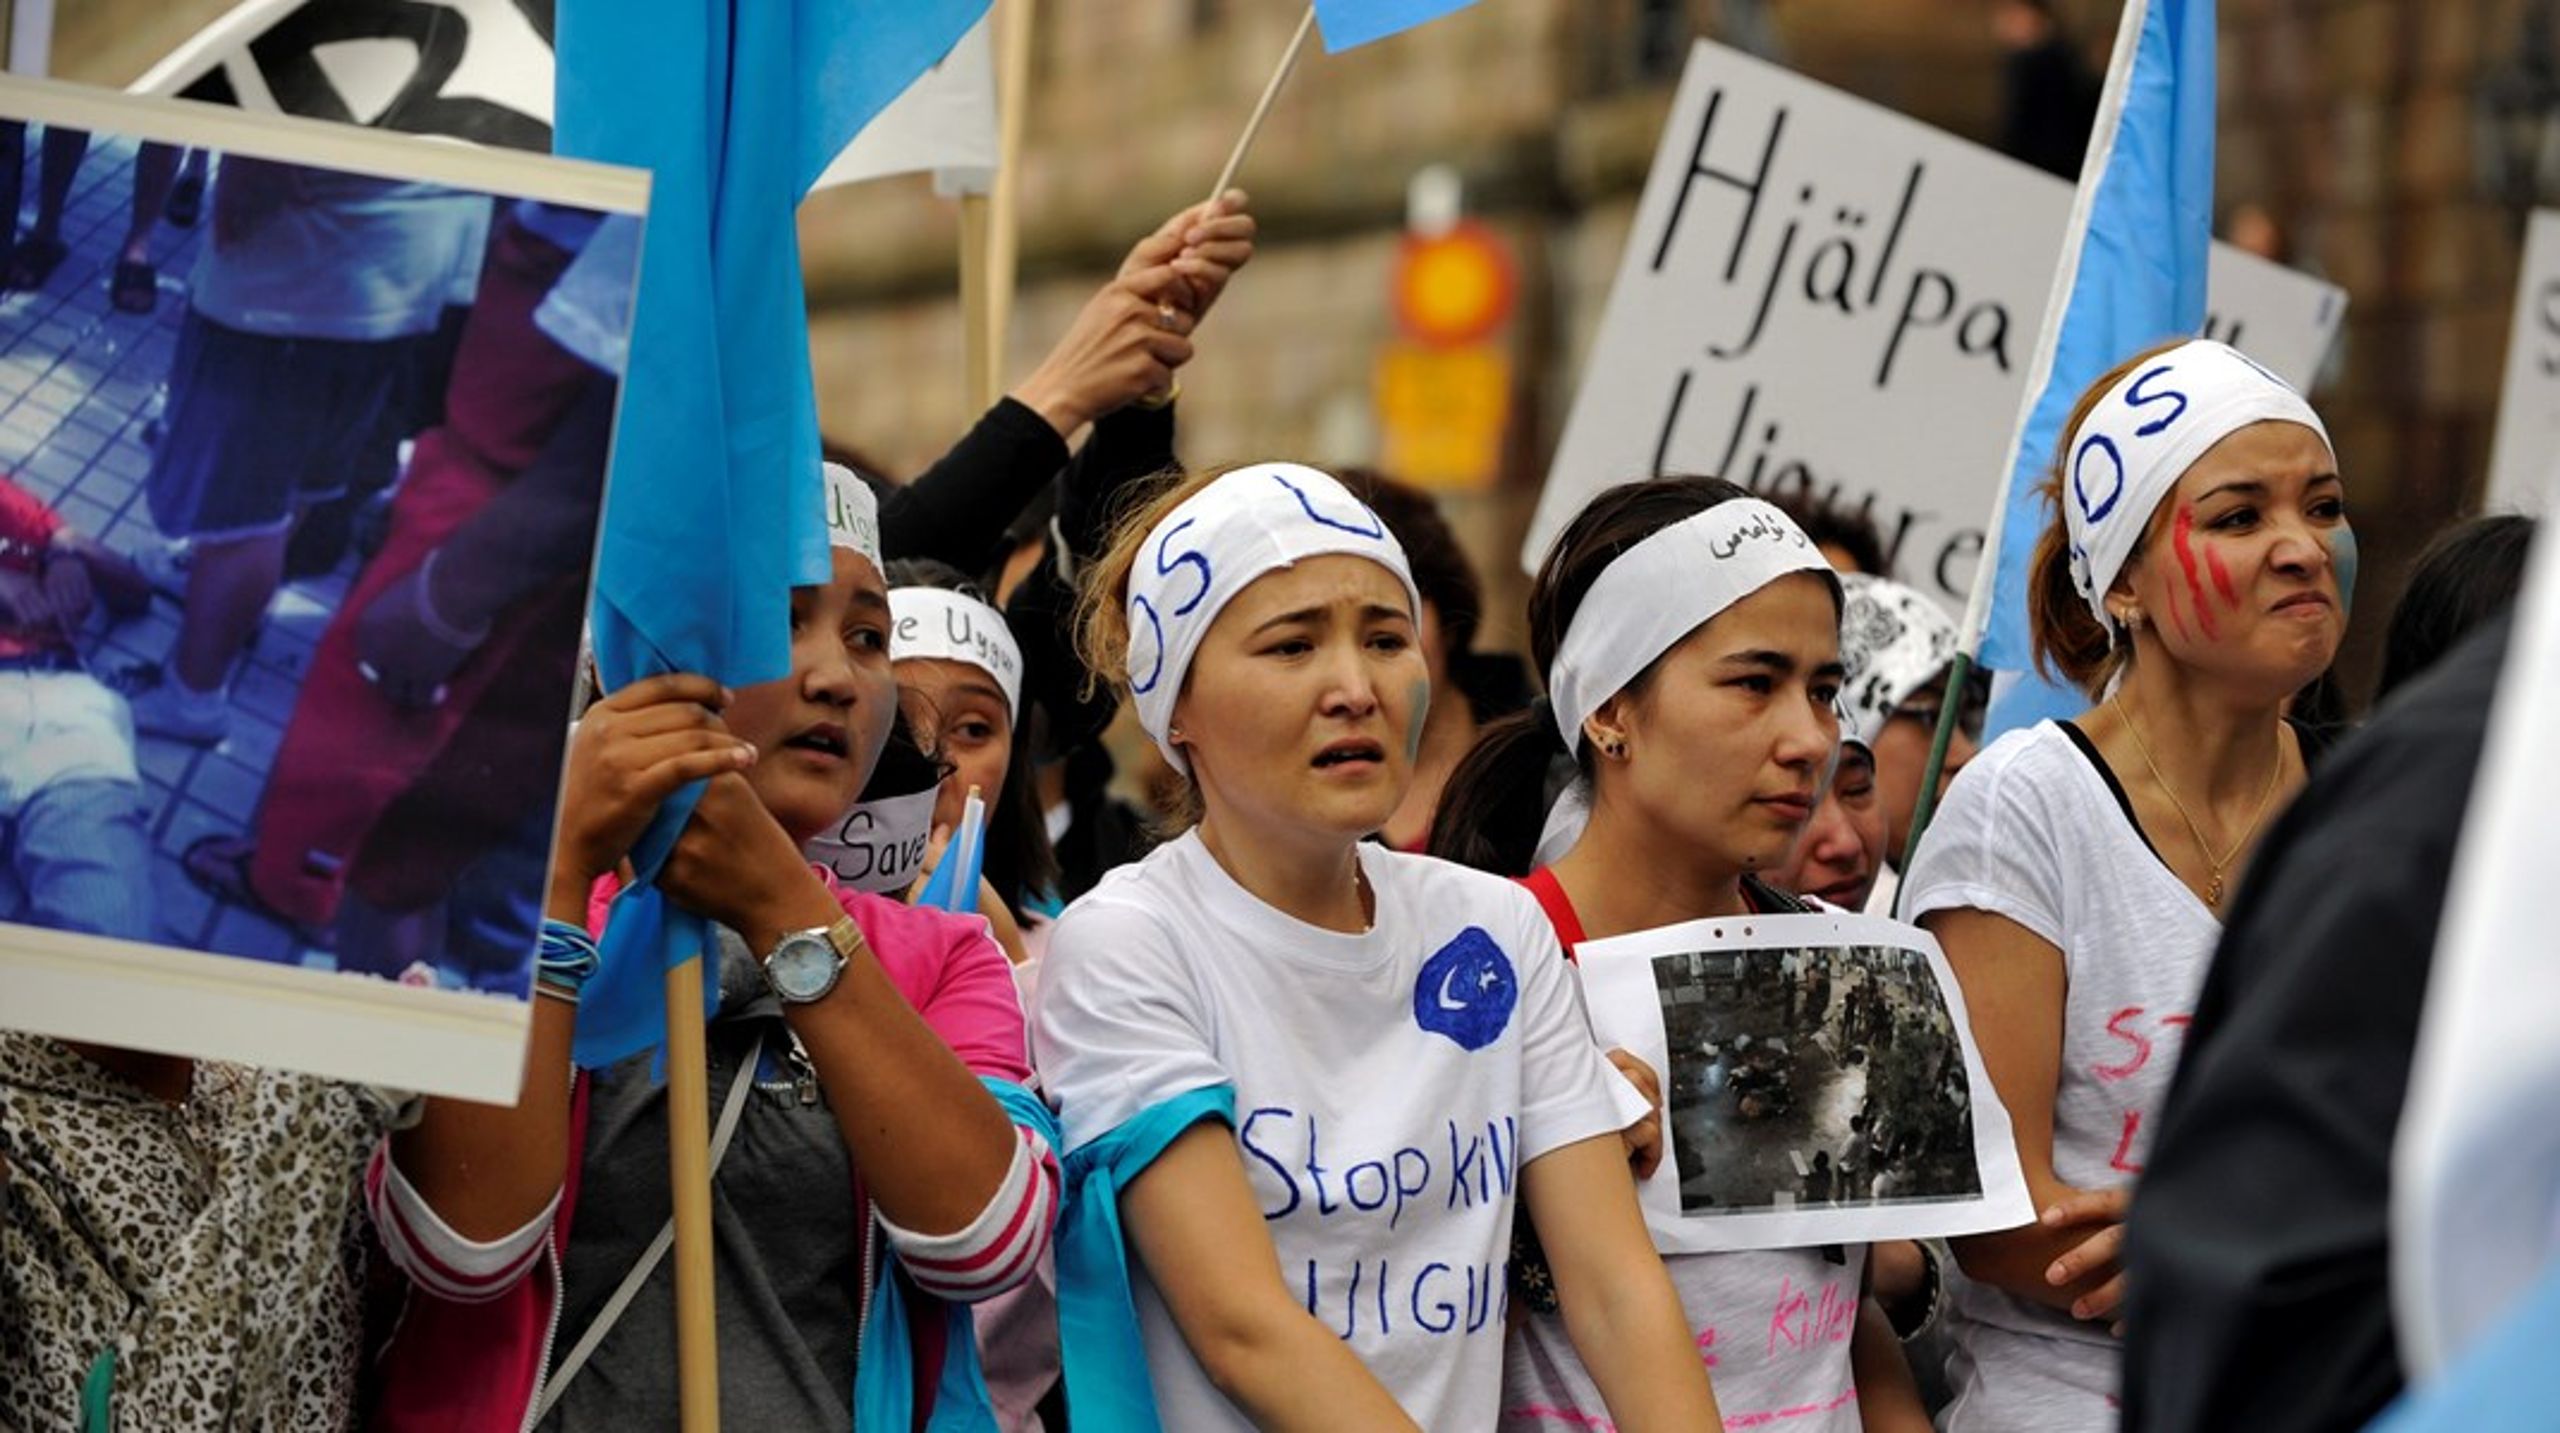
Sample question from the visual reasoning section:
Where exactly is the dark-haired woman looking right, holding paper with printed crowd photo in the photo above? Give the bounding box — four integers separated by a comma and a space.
1431, 479, 1928, 1433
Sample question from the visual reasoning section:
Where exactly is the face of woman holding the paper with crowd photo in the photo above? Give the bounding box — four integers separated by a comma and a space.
1585, 573, 1841, 873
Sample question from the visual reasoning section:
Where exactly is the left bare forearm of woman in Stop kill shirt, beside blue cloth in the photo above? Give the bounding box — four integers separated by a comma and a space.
1121, 1121, 1413, 1433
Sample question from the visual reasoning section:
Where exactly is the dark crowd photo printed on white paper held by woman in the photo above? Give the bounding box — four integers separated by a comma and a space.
1654, 947, 1981, 1215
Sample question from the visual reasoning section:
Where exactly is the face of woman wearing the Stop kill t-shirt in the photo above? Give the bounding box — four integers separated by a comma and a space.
1172, 553, 1431, 844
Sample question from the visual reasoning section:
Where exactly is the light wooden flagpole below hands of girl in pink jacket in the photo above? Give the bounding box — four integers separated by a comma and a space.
666, 952, 716, 1433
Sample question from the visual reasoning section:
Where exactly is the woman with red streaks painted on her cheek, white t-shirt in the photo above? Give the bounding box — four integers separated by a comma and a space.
1902, 340, 2355, 1433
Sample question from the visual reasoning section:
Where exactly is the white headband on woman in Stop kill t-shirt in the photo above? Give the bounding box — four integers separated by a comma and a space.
1129, 463, 1423, 775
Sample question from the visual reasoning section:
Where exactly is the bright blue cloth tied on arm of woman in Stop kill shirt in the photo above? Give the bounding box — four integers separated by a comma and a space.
1057, 1085, 1236, 1433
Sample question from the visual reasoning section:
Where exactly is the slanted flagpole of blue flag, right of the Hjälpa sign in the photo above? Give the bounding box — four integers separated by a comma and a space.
1902, 0, 2150, 890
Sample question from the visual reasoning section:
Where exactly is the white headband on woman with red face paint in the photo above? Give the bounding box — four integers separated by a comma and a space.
2063, 338, 2337, 642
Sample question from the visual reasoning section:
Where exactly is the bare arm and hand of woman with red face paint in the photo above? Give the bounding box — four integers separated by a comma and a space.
1920, 908, 2127, 1320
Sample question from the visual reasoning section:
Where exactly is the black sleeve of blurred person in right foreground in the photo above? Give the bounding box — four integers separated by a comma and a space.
2125, 621, 2504, 1433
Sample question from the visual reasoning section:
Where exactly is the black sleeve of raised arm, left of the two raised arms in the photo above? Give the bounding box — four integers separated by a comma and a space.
881, 397, 1068, 573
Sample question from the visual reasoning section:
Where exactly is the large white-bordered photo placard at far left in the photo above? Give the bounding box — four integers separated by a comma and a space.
0, 82, 648, 1100
